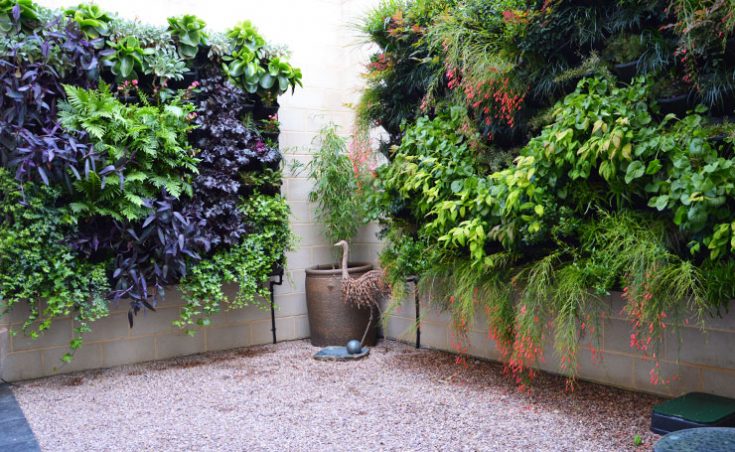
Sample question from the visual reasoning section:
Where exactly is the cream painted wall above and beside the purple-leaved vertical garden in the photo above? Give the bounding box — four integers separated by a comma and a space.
37, 0, 379, 328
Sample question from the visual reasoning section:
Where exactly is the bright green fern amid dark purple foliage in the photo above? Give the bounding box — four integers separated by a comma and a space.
59, 83, 198, 220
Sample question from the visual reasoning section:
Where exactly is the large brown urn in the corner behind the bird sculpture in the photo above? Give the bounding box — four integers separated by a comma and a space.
306, 262, 378, 347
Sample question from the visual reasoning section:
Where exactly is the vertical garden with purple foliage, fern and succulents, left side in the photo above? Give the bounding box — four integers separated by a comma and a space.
0, 0, 301, 360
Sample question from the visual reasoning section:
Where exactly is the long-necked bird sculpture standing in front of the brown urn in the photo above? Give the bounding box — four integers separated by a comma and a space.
334, 240, 391, 346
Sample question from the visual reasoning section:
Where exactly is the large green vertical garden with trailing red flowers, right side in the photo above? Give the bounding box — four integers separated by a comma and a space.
358, 0, 735, 383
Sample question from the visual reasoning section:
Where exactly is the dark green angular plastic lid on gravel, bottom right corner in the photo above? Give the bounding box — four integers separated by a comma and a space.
653, 392, 735, 425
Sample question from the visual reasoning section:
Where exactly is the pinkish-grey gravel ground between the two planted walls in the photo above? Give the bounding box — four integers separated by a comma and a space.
14, 341, 659, 451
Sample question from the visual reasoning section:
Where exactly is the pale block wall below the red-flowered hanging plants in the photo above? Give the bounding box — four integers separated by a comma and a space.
385, 293, 735, 397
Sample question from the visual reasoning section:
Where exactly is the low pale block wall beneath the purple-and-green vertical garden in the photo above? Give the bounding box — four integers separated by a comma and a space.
0, 287, 309, 381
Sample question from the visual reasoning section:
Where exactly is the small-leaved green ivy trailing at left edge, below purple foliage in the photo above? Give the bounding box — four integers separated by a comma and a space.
0, 168, 109, 360
